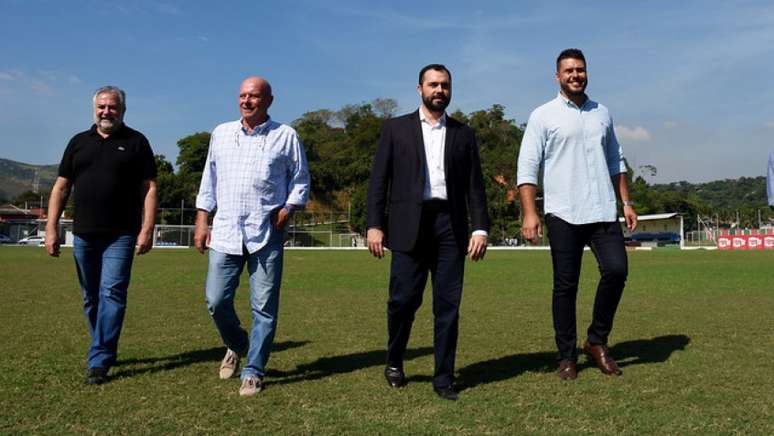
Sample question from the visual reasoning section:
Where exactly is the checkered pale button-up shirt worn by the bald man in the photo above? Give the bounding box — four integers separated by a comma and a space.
196, 119, 309, 255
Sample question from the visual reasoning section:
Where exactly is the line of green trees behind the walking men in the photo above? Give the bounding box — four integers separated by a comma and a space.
9, 98, 774, 241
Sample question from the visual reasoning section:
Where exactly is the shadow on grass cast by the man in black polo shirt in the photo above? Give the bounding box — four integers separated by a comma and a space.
110, 341, 309, 379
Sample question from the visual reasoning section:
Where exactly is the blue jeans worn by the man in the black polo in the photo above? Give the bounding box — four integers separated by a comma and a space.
73, 235, 136, 369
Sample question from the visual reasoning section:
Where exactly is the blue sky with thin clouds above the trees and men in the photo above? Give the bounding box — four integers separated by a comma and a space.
0, 0, 774, 183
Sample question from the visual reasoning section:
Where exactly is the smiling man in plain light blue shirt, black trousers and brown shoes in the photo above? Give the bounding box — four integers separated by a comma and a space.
517, 49, 637, 380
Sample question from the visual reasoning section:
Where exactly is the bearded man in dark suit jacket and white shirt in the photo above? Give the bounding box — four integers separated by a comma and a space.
367, 64, 489, 400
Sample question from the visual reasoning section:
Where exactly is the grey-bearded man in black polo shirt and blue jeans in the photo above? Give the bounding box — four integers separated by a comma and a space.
46, 86, 158, 384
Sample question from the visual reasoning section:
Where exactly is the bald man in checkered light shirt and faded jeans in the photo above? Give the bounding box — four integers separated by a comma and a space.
194, 77, 309, 396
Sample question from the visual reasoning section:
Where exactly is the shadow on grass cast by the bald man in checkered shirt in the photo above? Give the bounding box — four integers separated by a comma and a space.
267, 347, 433, 384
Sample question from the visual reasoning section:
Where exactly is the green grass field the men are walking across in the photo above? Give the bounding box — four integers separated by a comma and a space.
0, 247, 774, 434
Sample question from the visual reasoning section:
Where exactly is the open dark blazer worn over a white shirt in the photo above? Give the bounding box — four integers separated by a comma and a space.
366, 111, 489, 253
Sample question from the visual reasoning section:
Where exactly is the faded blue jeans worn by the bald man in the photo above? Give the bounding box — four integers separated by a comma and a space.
205, 232, 284, 378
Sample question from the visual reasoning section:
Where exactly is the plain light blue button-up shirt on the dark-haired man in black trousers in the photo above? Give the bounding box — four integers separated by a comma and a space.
516, 93, 626, 224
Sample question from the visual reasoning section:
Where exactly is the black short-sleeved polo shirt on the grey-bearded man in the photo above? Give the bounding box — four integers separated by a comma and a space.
59, 125, 156, 235
